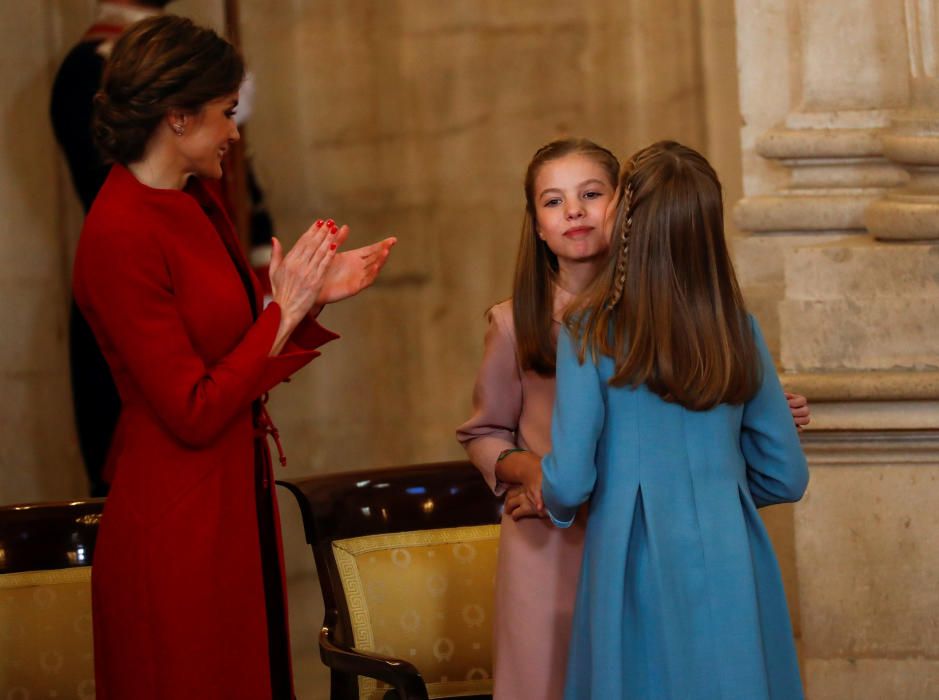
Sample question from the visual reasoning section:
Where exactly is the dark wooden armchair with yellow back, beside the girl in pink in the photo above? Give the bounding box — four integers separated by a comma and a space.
280, 462, 502, 700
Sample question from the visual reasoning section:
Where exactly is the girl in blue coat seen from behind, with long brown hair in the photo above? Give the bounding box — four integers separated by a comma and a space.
542, 142, 808, 700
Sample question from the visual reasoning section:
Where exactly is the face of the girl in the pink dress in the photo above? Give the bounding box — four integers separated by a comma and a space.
534, 153, 615, 265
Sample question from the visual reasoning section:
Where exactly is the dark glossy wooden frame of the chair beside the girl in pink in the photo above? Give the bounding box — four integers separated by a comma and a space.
277, 461, 502, 700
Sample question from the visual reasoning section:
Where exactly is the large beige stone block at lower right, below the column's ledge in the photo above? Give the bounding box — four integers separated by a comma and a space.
795, 464, 939, 656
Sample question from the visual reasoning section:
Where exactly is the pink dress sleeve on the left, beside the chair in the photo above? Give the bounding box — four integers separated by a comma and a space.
456, 302, 522, 496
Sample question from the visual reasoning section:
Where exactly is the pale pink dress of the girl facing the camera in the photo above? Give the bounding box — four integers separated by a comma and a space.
457, 287, 586, 700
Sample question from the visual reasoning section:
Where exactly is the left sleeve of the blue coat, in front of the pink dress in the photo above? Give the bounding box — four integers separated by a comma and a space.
541, 328, 606, 527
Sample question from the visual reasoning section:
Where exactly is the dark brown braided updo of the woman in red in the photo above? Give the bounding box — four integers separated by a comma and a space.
93, 15, 244, 165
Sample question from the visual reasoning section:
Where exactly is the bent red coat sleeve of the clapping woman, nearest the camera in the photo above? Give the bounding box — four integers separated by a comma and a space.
74, 221, 338, 447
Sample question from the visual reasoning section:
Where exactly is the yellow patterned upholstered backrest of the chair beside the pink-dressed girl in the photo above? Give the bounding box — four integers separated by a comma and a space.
332, 525, 499, 700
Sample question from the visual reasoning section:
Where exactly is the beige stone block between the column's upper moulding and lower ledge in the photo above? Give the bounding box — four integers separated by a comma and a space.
779, 293, 939, 371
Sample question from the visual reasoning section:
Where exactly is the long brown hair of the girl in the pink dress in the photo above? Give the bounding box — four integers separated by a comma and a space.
512, 139, 619, 377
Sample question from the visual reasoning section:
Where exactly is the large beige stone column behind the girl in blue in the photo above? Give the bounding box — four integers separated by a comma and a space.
736, 0, 939, 700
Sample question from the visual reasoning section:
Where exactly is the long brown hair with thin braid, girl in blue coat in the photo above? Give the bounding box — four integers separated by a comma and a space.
565, 141, 760, 410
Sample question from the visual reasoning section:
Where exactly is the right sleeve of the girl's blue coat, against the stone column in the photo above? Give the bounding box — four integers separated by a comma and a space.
740, 317, 809, 507
